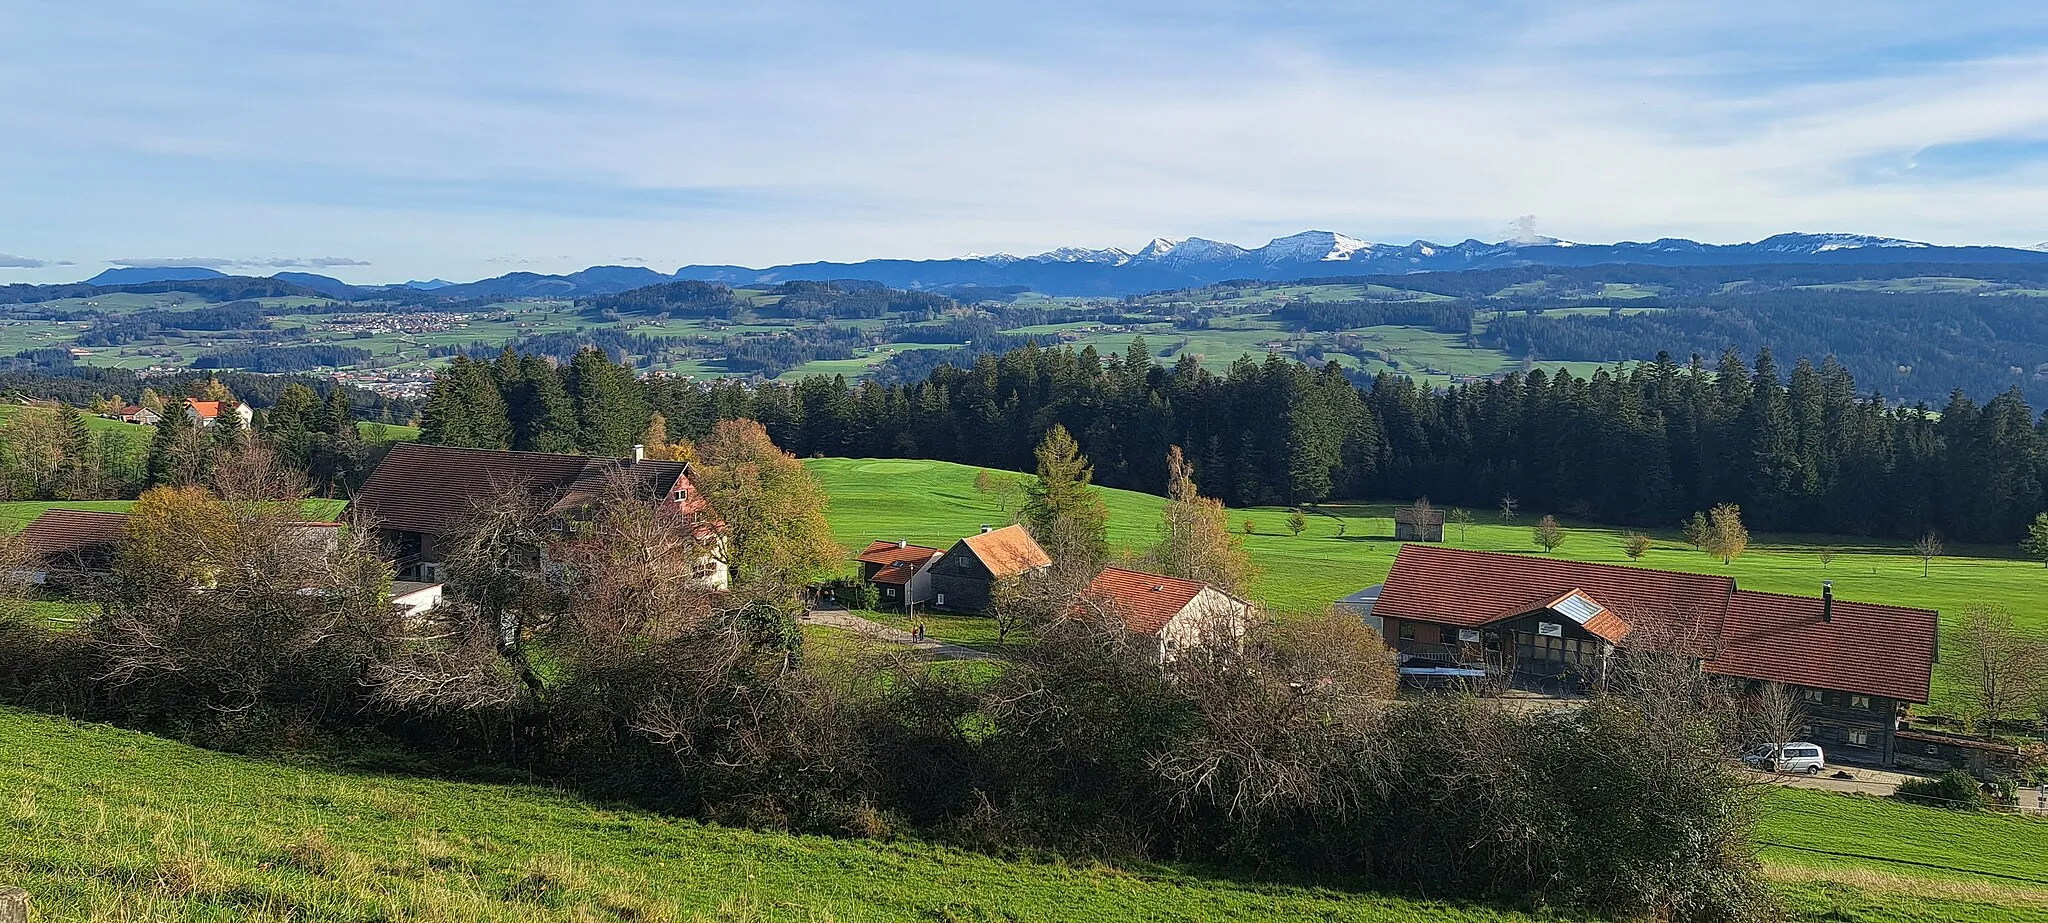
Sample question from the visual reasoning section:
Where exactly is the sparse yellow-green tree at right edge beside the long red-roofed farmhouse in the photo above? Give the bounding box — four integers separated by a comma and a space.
1937, 606, 2048, 737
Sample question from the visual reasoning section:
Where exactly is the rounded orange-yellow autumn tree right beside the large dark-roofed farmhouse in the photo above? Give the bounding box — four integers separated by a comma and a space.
696, 420, 846, 606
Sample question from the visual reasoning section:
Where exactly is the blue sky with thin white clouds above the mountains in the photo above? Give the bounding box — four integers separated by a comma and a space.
0, 0, 2048, 282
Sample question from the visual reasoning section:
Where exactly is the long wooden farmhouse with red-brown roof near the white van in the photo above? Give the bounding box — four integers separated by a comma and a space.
1352, 544, 1935, 763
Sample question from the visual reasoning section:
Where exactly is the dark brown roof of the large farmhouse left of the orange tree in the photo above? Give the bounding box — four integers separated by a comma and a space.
350, 442, 709, 534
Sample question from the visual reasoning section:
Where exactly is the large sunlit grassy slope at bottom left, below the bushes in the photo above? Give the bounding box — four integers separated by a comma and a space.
0, 710, 1554, 923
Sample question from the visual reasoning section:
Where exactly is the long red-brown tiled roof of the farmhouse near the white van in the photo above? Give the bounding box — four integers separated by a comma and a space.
1372, 544, 1937, 702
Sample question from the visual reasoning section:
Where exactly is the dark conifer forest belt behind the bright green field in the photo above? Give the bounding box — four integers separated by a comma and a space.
424, 340, 2048, 542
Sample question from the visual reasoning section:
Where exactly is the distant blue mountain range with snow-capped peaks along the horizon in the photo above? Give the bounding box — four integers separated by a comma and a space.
72, 231, 2048, 299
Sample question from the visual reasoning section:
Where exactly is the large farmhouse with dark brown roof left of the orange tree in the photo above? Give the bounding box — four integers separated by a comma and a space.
348, 442, 729, 589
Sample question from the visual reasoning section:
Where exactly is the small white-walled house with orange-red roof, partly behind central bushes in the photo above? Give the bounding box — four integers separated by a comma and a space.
1075, 567, 1251, 663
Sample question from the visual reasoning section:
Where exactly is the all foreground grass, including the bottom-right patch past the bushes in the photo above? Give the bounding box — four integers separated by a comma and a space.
0, 708, 2048, 923
